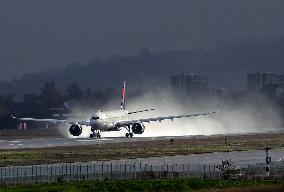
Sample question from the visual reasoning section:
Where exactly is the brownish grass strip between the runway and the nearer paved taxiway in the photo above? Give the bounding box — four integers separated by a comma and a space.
0, 134, 284, 166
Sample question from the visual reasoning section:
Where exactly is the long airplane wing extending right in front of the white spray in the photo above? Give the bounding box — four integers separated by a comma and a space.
116, 111, 219, 126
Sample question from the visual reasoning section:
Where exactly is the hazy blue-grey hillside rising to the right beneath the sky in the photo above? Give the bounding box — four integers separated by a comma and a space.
0, 37, 284, 94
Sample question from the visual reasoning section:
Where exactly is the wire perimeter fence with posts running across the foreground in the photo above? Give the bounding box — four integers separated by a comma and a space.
0, 161, 284, 184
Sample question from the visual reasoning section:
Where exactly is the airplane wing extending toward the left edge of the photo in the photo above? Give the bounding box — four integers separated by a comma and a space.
11, 115, 90, 126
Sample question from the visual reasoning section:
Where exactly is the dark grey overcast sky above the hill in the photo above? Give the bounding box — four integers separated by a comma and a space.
0, 0, 284, 80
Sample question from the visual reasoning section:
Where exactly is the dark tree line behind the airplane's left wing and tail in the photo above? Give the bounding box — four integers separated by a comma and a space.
0, 82, 119, 129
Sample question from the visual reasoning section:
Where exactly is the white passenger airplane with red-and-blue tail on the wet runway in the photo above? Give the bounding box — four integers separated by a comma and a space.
11, 81, 219, 138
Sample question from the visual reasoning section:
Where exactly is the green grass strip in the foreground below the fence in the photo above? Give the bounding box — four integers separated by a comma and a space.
0, 178, 284, 192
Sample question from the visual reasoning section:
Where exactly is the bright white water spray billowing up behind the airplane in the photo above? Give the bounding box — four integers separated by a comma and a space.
60, 89, 281, 137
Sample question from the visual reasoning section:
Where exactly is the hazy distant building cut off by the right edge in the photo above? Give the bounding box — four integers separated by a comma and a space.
247, 71, 284, 95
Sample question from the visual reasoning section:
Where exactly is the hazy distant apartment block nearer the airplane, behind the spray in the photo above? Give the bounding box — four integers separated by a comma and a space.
171, 73, 208, 96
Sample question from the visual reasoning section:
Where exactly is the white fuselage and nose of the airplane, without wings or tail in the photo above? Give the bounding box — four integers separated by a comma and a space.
90, 110, 128, 131
